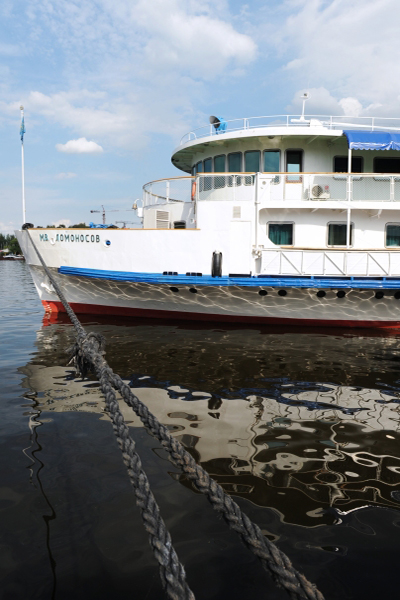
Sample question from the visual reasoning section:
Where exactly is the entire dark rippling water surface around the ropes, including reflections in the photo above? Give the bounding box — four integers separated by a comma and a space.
0, 262, 400, 600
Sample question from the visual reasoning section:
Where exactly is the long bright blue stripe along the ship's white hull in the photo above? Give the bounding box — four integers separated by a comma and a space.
58, 267, 400, 290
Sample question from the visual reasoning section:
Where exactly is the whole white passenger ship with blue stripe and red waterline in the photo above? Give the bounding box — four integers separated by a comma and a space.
16, 111, 400, 327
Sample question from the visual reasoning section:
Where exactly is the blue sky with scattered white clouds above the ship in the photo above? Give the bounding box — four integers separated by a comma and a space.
0, 0, 400, 233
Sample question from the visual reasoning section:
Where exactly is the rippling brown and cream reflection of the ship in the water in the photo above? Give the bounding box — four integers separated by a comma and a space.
22, 317, 400, 527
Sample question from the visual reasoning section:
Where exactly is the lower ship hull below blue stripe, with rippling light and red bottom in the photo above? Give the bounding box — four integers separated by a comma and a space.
30, 266, 400, 328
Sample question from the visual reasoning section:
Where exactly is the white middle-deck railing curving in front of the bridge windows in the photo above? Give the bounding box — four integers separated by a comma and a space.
143, 173, 400, 207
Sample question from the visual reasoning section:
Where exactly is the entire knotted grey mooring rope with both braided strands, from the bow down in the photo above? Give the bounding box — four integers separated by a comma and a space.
27, 230, 324, 600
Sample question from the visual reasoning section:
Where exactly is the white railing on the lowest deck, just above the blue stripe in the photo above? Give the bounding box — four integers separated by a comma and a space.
261, 249, 400, 277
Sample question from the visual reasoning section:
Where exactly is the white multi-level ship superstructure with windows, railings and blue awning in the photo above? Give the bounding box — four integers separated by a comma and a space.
143, 115, 400, 277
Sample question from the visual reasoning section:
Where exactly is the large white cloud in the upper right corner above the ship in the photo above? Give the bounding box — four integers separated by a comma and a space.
272, 0, 400, 116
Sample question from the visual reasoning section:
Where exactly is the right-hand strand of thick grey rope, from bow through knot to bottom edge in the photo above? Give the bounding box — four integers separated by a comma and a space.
28, 232, 324, 600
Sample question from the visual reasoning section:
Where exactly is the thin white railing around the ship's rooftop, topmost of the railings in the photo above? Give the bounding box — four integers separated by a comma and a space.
180, 115, 400, 145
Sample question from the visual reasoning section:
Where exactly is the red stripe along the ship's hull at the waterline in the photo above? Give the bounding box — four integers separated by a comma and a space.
42, 300, 400, 329
